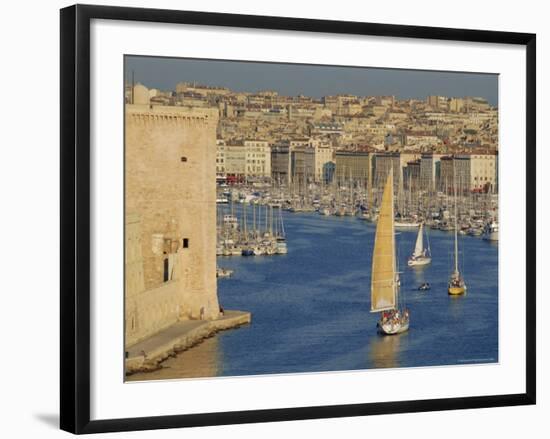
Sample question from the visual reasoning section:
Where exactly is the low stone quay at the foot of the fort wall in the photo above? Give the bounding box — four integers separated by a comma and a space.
125, 310, 252, 375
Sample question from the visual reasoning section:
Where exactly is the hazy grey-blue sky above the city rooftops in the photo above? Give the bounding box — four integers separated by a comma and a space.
126, 56, 498, 105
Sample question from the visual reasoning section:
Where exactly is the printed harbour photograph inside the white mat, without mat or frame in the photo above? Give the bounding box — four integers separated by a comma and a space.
123, 54, 502, 383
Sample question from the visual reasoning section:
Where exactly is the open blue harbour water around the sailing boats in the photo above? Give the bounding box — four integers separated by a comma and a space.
135, 212, 498, 379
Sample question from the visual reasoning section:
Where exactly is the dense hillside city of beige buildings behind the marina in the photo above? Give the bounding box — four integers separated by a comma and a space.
126, 82, 498, 192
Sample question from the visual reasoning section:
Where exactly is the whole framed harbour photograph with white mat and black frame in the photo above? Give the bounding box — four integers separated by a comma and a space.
61, 5, 536, 433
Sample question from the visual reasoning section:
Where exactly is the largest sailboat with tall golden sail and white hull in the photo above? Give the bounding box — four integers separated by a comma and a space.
371, 171, 409, 335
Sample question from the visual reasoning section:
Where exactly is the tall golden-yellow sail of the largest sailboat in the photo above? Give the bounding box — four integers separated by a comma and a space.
371, 169, 397, 312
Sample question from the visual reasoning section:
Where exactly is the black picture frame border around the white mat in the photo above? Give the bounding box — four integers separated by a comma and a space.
60, 5, 536, 434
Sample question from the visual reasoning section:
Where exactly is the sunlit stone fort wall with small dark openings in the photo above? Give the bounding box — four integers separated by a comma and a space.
125, 104, 219, 346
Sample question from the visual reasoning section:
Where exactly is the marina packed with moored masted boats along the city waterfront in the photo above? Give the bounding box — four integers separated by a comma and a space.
217, 175, 498, 256
